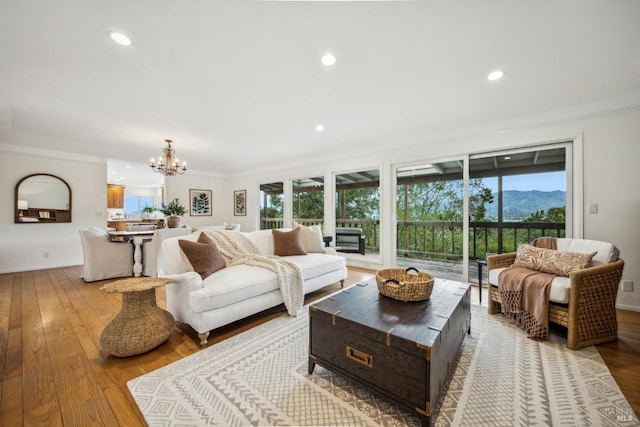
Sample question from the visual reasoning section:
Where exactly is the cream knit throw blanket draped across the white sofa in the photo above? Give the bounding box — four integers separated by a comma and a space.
202, 230, 304, 316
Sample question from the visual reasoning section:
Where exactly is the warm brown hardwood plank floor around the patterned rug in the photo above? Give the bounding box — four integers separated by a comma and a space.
0, 267, 640, 427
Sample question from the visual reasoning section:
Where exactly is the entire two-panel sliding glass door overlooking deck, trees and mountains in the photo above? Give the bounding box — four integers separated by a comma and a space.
395, 143, 572, 282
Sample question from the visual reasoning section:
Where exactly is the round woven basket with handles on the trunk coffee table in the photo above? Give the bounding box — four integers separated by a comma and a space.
376, 267, 433, 302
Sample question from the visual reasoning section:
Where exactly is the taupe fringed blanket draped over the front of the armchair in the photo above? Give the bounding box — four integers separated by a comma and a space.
498, 267, 556, 340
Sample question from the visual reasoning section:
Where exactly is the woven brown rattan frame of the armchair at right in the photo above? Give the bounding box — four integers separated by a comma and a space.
487, 244, 624, 350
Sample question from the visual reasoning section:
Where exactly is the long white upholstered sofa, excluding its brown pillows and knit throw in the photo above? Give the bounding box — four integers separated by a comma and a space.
159, 229, 347, 345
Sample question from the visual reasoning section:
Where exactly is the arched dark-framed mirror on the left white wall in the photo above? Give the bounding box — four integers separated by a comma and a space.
14, 173, 71, 224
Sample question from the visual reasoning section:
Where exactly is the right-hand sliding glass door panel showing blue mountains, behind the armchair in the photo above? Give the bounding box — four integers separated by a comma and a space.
469, 144, 571, 279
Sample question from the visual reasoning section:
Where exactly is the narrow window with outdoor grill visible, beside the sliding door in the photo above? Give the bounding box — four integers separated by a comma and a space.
336, 169, 380, 254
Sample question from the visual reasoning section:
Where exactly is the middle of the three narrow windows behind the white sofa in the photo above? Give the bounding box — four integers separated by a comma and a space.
292, 177, 324, 225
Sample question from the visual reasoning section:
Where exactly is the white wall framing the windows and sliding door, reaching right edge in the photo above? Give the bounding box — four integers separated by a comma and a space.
230, 110, 640, 311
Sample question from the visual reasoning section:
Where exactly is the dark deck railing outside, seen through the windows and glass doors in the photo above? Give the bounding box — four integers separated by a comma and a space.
262, 218, 565, 260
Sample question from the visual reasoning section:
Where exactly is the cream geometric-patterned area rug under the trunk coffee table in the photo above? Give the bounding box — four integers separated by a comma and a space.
128, 305, 639, 427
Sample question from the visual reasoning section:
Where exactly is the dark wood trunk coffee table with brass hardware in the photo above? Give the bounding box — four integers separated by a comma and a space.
309, 279, 471, 425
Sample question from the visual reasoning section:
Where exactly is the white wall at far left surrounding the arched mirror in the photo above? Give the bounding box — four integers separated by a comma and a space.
0, 144, 107, 273
